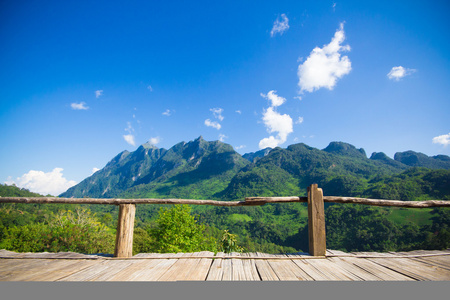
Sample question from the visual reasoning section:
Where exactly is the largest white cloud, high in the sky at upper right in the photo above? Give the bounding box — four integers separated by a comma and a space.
297, 23, 352, 93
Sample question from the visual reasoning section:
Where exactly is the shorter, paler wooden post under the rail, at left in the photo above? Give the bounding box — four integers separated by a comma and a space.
114, 204, 136, 257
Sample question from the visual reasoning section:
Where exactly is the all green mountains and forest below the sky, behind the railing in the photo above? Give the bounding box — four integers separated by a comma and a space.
0, 137, 450, 253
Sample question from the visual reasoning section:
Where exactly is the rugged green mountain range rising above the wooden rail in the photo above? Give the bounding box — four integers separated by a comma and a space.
60, 136, 450, 200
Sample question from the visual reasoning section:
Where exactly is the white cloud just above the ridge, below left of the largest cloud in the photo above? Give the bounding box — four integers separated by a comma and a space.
259, 107, 294, 149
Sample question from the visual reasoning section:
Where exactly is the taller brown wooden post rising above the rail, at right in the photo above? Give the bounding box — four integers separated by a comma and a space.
308, 184, 326, 256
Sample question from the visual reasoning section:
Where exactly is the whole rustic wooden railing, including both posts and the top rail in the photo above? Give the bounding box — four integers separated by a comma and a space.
0, 184, 450, 257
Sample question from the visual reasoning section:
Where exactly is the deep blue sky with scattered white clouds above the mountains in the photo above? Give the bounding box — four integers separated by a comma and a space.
0, 0, 450, 195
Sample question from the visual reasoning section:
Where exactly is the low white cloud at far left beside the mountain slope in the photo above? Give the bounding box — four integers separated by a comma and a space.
5, 168, 77, 196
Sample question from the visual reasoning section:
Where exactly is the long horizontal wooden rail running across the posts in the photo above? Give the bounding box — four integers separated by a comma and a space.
0, 196, 450, 208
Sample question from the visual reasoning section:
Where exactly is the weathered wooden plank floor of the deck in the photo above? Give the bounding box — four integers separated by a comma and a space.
0, 249, 450, 281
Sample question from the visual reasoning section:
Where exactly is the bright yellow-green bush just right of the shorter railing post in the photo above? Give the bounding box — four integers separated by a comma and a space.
149, 205, 216, 253
